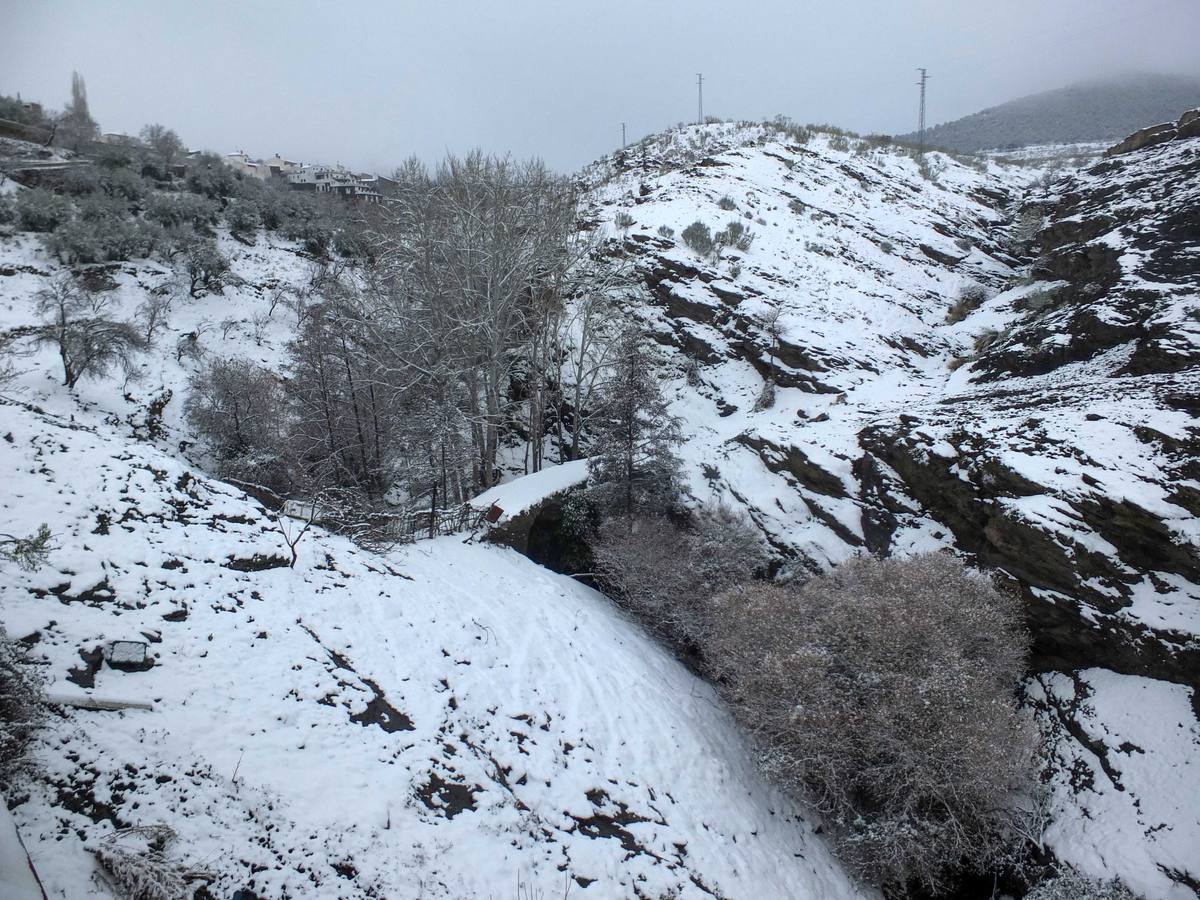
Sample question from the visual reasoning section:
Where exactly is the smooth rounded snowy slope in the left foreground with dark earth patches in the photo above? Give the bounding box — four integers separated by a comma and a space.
0, 404, 856, 898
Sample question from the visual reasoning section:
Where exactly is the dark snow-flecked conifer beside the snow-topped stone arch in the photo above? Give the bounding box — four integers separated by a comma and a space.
590, 329, 683, 517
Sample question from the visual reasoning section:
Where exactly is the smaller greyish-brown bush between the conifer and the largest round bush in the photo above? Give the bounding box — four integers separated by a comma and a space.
593, 505, 766, 652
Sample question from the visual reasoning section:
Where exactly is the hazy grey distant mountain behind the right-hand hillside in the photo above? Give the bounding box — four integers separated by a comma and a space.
902, 74, 1200, 151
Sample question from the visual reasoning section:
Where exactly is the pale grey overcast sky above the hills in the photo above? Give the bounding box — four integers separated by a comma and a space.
0, 0, 1200, 172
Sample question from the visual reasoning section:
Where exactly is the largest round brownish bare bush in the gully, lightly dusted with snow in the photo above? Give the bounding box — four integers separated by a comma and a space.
707, 553, 1036, 890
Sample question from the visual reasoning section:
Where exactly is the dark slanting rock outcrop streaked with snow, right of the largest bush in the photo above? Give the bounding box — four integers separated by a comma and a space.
857, 379, 1200, 685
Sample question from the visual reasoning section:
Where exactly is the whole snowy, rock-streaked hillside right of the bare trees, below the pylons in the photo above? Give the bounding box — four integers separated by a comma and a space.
585, 125, 1200, 898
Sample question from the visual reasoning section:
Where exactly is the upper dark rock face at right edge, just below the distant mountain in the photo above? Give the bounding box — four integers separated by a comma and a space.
974, 116, 1200, 380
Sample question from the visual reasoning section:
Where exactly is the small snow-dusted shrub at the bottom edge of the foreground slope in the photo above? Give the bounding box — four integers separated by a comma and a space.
91, 824, 211, 900
